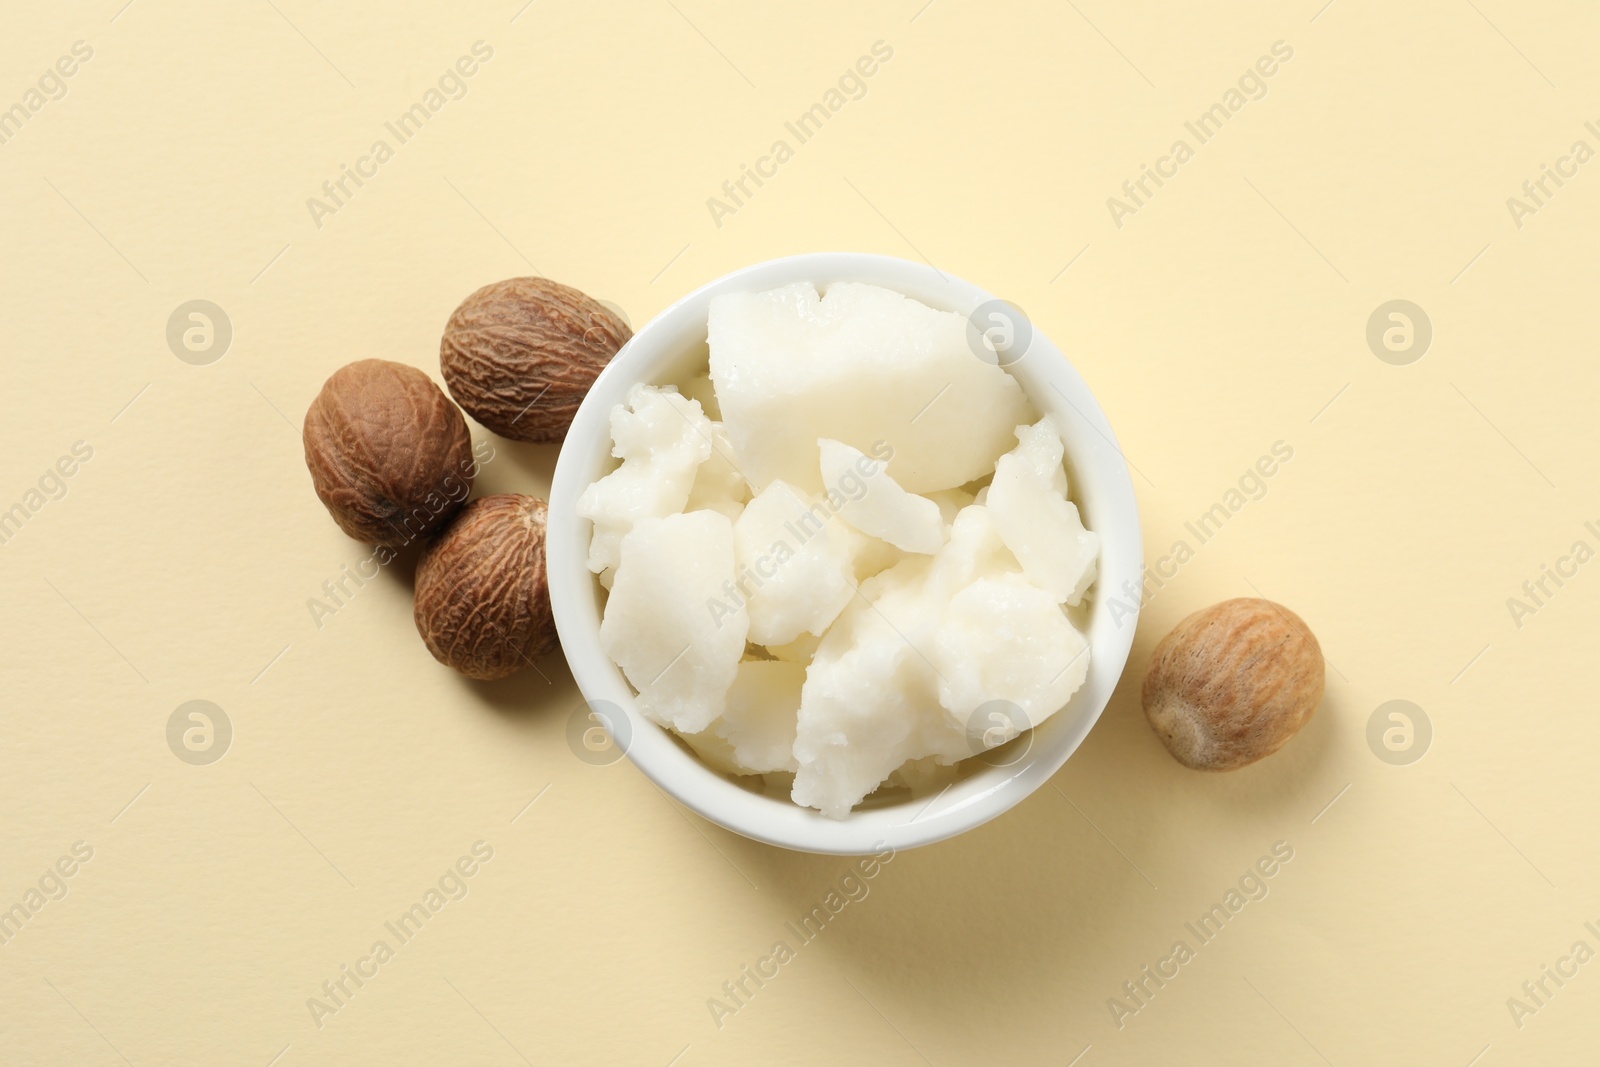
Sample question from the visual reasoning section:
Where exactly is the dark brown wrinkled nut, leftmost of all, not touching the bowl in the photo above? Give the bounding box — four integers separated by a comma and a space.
302, 360, 477, 547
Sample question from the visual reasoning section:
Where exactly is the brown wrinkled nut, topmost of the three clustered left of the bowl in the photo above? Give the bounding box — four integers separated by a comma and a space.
438, 278, 634, 442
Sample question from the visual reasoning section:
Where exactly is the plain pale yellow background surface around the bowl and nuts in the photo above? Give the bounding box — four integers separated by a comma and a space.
0, 0, 1600, 1067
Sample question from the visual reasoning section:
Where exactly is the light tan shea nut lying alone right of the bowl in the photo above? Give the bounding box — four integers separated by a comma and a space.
1144, 598, 1323, 771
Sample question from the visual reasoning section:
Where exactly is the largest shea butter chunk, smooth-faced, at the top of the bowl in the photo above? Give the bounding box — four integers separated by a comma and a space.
707, 282, 1032, 493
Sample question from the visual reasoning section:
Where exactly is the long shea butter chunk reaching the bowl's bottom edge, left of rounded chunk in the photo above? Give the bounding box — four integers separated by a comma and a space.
790, 506, 1017, 819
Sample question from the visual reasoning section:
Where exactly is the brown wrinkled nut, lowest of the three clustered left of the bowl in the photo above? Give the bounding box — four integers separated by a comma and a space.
416, 493, 557, 680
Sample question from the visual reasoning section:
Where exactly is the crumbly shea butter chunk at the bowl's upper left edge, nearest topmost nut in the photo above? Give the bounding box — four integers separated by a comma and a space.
578, 384, 712, 574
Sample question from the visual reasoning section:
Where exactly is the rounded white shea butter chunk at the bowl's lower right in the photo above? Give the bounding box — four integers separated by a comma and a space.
931, 573, 1090, 735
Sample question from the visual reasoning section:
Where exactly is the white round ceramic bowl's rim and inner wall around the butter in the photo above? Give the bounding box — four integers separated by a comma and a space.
547, 253, 1144, 854
